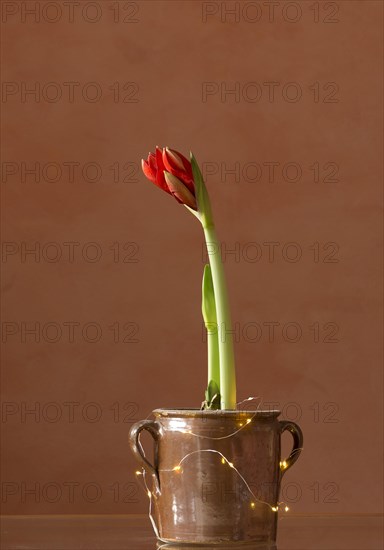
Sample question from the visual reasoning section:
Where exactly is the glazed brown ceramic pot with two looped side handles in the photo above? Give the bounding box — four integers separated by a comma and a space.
129, 409, 303, 547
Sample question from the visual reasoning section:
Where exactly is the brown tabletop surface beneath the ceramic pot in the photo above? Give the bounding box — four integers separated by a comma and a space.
1, 515, 383, 550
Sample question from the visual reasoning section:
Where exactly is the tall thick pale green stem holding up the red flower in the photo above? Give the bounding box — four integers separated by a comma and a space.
203, 225, 236, 409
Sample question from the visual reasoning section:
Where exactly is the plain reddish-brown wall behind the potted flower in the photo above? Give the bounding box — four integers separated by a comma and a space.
1, 0, 382, 514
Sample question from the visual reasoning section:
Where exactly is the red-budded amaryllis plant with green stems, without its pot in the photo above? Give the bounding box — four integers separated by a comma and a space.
142, 147, 236, 409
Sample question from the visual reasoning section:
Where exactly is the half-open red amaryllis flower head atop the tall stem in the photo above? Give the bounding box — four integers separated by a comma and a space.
141, 147, 197, 210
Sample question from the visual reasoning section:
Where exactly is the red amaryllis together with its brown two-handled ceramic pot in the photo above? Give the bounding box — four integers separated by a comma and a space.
130, 147, 303, 546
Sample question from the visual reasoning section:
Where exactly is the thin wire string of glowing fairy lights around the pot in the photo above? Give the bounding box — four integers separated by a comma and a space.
135, 397, 301, 542
